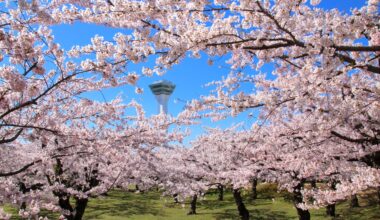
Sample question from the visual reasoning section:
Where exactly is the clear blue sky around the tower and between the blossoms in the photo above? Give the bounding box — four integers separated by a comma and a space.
53, 0, 365, 144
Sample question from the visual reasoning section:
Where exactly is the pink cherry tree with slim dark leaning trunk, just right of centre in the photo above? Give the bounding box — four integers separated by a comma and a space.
193, 127, 256, 219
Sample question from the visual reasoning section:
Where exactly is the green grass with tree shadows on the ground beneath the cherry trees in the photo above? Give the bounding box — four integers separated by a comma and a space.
6, 184, 380, 220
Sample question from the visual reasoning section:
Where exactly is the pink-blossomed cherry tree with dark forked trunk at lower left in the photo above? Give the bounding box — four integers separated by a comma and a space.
2, 98, 190, 219
